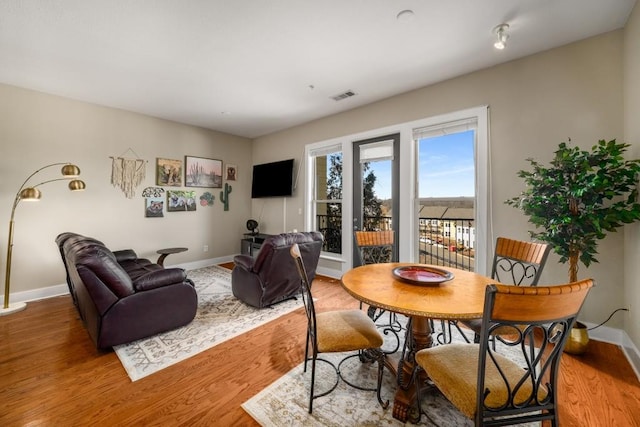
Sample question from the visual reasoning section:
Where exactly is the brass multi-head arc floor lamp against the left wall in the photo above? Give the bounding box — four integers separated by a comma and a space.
0, 163, 85, 316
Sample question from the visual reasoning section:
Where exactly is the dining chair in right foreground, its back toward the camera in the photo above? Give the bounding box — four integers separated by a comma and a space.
415, 279, 593, 426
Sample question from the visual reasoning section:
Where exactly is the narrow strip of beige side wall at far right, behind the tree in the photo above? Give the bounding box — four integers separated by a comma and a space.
623, 3, 640, 354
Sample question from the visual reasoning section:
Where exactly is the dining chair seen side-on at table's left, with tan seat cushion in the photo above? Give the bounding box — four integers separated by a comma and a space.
290, 244, 389, 413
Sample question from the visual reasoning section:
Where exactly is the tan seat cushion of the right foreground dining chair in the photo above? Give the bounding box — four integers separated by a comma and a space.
416, 344, 547, 419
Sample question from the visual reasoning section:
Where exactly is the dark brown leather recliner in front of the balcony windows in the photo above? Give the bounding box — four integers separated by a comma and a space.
231, 231, 323, 308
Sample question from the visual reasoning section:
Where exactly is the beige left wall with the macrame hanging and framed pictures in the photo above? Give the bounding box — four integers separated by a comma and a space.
0, 85, 252, 301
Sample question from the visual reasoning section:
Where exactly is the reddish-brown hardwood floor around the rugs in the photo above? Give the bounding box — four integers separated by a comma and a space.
0, 265, 640, 427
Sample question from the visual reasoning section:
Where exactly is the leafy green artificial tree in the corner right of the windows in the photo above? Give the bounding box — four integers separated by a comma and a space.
506, 139, 640, 353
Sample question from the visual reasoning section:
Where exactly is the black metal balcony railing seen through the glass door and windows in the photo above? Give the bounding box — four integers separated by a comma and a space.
317, 215, 475, 271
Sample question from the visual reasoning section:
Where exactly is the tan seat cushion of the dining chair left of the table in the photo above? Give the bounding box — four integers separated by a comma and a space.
316, 310, 383, 353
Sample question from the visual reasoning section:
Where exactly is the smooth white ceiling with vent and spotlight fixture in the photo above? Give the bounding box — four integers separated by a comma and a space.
0, 0, 635, 138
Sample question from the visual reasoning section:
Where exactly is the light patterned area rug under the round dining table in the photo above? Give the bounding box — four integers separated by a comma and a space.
242, 322, 540, 427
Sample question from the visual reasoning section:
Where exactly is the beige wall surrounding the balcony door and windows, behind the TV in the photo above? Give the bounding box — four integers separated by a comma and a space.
253, 31, 624, 327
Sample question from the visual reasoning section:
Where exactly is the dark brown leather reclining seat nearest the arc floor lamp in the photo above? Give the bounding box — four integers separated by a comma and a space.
56, 233, 198, 349
